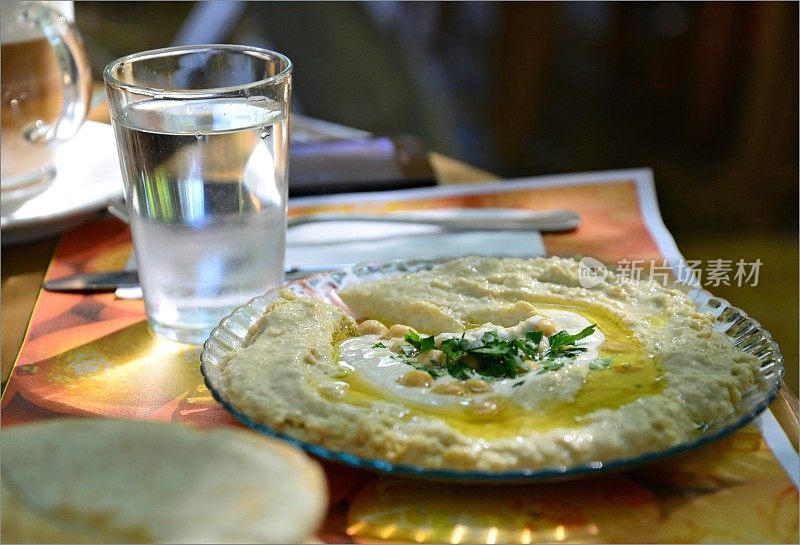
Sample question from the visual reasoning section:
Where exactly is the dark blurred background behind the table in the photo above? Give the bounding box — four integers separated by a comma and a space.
75, 1, 798, 392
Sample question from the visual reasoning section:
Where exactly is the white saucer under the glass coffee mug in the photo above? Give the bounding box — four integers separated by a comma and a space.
0, 121, 122, 244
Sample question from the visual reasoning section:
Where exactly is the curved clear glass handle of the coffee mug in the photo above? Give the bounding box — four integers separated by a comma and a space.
17, 2, 92, 144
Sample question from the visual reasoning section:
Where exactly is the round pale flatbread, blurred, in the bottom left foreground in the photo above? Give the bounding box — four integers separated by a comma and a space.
0, 418, 326, 543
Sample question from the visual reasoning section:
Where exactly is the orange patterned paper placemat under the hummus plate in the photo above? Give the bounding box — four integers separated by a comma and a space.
1, 171, 798, 543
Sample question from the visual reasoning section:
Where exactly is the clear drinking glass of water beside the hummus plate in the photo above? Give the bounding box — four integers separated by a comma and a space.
103, 45, 292, 343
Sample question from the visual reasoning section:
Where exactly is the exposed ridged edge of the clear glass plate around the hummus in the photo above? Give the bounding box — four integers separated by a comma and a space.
200, 259, 783, 483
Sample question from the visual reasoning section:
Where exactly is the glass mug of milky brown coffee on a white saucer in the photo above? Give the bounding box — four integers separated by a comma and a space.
0, 0, 92, 215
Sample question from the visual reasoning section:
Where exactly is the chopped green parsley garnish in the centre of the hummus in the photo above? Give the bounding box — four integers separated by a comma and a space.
400, 324, 596, 378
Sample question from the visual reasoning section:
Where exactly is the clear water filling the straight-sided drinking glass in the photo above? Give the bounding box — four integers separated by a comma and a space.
115, 97, 289, 342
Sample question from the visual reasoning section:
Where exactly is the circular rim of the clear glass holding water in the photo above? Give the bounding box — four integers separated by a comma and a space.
103, 44, 293, 98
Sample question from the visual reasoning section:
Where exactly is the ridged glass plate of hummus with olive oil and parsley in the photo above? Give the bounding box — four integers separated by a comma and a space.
201, 256, 783, 482
